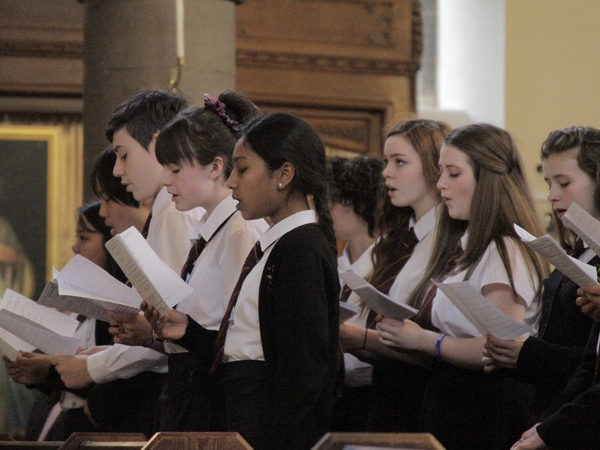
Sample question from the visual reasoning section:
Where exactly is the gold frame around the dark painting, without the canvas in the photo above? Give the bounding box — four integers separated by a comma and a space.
0, 124, 83, 291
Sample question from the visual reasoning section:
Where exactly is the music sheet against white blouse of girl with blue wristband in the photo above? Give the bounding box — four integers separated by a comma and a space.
434, 281, 533, 339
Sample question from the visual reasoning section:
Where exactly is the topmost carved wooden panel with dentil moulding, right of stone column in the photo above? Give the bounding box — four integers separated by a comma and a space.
237, 0, 421, 75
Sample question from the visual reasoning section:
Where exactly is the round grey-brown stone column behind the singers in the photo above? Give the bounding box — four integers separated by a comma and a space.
83, 0, 238, 200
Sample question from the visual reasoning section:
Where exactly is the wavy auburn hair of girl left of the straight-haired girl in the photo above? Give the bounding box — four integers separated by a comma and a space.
371, 119, 450, 280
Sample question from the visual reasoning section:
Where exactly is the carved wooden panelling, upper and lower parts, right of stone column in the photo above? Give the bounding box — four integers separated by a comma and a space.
236, 0, 422, 157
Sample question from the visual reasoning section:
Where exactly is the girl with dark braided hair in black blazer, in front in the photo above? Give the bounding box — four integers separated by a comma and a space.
146, 114, 340, 450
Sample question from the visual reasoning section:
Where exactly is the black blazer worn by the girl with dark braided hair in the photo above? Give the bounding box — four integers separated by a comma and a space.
178, 224, 340, 449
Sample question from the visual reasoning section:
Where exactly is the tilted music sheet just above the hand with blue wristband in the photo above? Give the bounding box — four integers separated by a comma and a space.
340, 270, 419, 320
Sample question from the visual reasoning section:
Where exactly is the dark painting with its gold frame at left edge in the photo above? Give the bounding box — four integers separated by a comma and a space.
0, 125, 83, 300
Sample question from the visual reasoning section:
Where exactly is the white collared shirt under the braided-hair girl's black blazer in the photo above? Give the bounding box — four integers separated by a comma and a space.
224, 210, 317, 361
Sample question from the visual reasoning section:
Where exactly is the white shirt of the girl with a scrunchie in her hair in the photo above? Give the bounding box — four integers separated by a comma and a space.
165, 195, 268, 353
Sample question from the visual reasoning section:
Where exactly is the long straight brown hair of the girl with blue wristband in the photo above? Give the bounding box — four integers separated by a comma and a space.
408, 124, 548, 307
